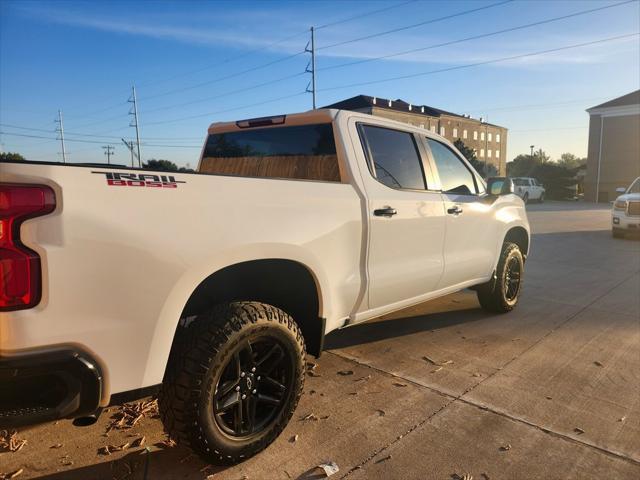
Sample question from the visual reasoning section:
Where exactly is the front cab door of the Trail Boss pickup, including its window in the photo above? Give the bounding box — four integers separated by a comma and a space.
426, 138, 501, 289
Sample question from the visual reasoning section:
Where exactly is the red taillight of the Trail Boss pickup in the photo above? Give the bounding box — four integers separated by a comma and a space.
0, 183, 56, 311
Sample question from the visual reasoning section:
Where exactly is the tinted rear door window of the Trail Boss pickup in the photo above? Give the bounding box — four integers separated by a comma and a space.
361, 125, 425, 190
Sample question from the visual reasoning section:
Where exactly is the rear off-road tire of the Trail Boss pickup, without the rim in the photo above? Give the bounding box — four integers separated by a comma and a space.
158, 302, 306, 465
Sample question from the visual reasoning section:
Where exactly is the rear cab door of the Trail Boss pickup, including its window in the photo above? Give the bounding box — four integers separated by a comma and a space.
356, 120, 445, 310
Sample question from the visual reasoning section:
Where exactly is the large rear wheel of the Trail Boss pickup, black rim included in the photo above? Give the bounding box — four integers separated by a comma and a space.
159, 302, 305, 464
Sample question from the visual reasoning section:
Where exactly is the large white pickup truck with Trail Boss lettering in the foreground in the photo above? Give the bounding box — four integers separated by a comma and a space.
0, 109, 529, 463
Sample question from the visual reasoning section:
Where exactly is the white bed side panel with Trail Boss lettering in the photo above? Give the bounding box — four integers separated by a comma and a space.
0, 163, 362, 393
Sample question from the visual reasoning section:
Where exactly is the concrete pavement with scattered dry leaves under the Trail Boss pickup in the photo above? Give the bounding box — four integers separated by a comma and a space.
0, 203, 640, 480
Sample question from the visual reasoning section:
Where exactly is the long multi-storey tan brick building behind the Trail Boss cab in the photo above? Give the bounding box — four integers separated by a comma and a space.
325, 95, 507, 175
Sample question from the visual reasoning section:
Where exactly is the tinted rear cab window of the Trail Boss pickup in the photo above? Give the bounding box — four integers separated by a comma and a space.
199, 123, 341, 182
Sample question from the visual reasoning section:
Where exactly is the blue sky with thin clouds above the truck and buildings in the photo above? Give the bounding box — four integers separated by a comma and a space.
0, 0, 640, 166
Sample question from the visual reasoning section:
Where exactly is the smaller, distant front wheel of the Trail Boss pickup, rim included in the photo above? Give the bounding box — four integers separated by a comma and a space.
476, 242, 524, 313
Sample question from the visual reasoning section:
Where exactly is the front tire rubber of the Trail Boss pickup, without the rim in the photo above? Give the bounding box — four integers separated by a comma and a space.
476, 242, 524, 313
